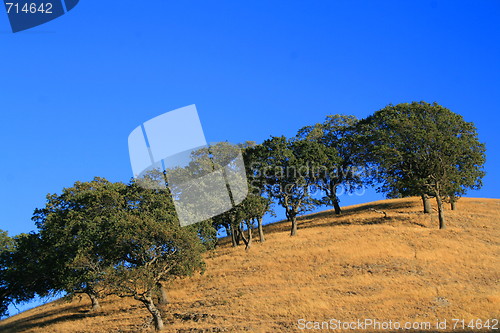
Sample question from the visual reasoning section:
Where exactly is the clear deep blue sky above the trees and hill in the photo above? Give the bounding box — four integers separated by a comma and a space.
0, 0, 500, 239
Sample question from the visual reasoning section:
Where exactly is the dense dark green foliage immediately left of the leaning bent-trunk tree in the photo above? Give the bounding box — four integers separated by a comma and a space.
29, 178, 126, 295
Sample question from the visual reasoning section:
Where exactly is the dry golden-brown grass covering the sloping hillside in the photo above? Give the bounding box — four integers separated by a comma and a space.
0, 198, 500, 333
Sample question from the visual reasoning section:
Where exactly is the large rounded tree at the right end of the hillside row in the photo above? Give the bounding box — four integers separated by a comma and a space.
360, 102, 485, 229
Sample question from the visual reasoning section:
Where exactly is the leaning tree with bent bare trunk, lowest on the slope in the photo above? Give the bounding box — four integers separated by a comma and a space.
104, 181, 205, 330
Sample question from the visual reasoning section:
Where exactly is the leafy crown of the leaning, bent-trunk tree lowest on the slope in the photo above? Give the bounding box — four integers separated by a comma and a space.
106, 215, 204, 298
